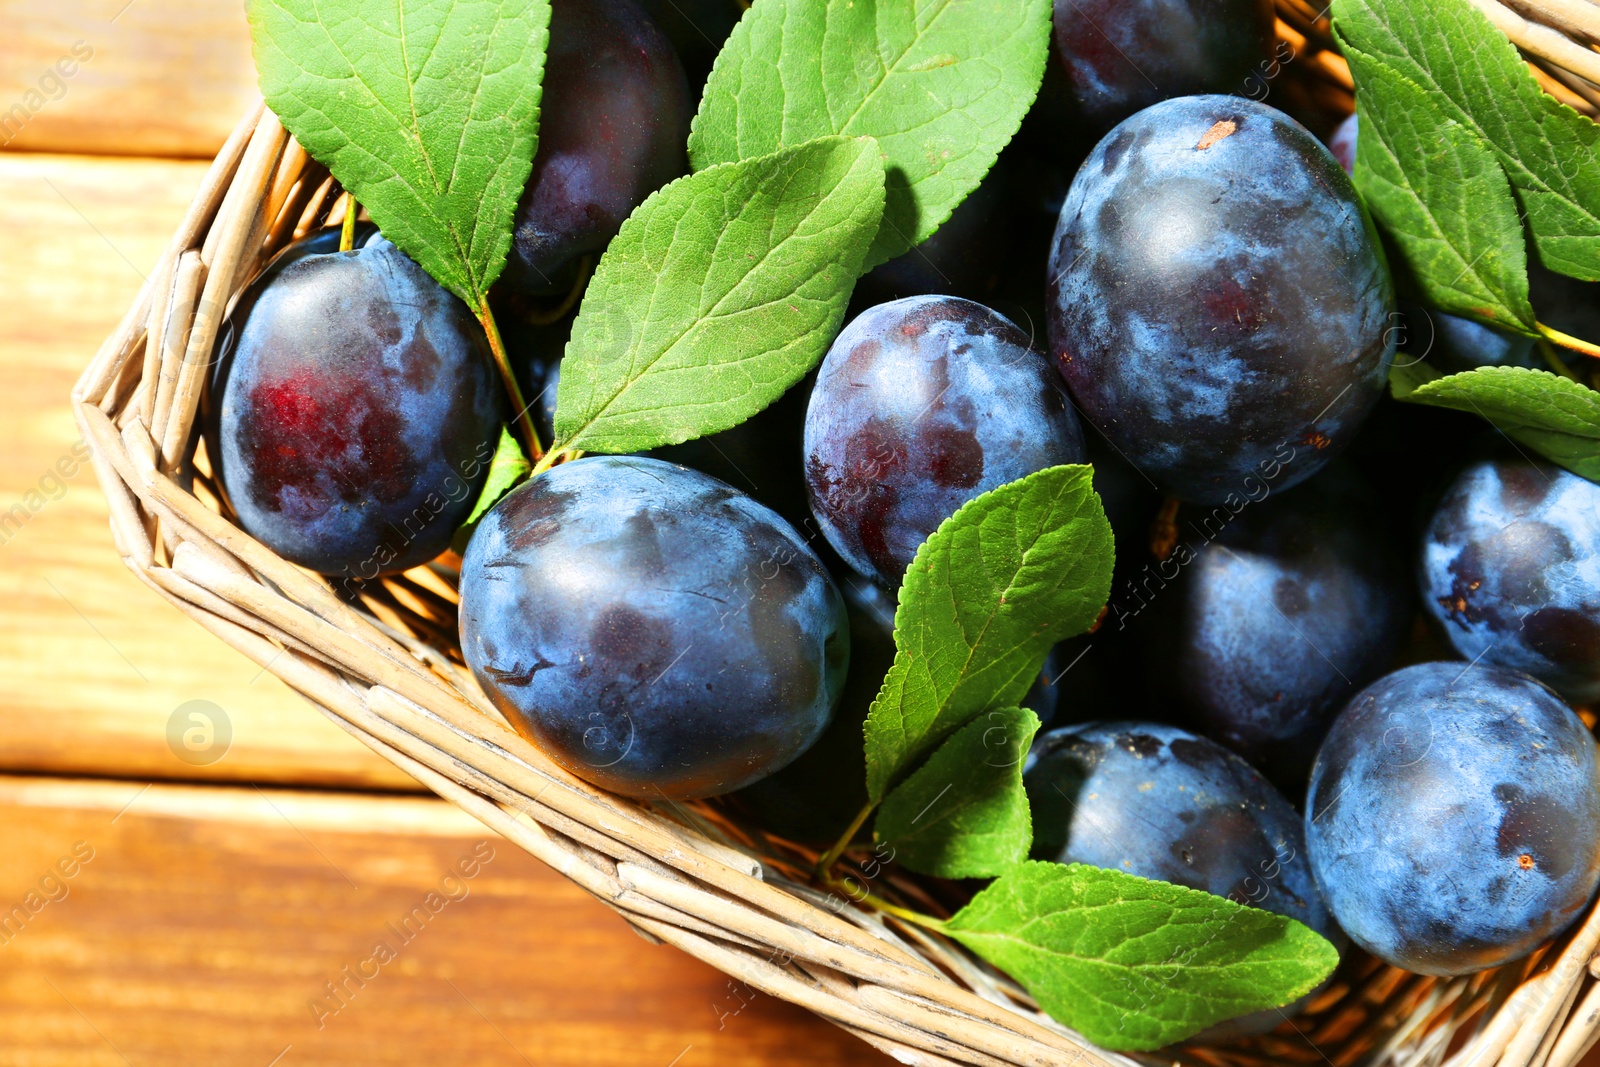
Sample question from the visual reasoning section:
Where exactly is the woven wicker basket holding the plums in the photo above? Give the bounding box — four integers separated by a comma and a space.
72, 0, 1600, 1067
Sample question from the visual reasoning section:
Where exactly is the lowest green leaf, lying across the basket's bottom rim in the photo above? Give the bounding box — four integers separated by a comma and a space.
944, 861, 1339, 1051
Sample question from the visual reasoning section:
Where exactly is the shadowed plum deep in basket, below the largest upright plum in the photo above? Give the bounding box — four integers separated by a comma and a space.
1141, 466, 1413, 792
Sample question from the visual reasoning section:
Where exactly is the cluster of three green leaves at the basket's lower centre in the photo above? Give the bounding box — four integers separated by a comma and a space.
864, 466, 1338, 1049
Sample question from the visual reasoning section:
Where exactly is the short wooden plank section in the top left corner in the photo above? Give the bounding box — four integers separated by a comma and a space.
0, 0, 256, 157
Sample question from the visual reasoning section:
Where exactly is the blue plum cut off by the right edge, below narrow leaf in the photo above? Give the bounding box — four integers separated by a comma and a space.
1419, 450, 1600, 701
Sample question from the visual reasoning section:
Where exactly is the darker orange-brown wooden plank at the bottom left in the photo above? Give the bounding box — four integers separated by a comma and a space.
0, 777, 890, 1067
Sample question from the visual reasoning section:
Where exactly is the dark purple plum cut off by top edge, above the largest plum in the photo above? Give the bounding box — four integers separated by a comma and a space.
1053, 0, 1274, 134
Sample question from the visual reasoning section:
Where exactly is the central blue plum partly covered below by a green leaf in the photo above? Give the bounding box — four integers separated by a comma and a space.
805, 296, 1086, 587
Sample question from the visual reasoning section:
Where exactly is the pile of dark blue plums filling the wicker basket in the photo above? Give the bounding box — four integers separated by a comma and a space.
208, 0, 1600, 1011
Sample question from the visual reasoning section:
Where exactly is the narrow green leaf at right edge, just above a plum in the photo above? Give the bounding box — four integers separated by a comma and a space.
1390, 366, 1600, 482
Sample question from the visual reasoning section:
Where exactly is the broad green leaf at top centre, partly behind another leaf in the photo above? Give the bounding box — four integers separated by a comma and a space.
690, 0, 1050, 269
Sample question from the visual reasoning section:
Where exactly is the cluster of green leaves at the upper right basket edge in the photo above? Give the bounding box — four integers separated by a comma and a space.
1333, 0, 1600, 478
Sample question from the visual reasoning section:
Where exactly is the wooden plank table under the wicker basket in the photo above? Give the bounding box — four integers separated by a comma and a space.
0, 0, 888, 1067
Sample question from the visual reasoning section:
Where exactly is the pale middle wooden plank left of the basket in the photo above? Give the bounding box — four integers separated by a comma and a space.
0, 151, 416, 789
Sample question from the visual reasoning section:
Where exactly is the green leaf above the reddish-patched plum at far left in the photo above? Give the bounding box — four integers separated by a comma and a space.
245, 0, 550, 312
